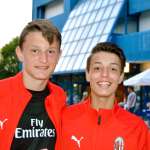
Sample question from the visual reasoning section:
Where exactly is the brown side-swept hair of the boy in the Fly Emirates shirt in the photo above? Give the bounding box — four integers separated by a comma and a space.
19, 19, 61, 48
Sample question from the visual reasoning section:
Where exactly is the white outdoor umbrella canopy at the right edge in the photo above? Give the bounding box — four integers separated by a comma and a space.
123, 69, 150, 86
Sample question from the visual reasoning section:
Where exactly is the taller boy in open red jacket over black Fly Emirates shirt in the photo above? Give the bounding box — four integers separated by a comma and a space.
0, 19, 66, 150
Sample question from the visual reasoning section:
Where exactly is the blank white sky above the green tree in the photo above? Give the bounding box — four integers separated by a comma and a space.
0, 0, 32, 48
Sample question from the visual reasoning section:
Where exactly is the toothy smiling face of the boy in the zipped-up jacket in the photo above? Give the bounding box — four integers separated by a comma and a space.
86, 52, 123, 99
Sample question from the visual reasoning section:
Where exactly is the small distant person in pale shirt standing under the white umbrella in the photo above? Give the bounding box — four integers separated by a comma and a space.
126, 86, 136, 113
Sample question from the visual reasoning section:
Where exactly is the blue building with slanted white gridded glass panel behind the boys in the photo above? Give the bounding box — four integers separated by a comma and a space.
32, 0, 150, 120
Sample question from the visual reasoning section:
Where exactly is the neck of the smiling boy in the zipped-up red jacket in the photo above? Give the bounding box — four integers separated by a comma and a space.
91, 95, 115, 110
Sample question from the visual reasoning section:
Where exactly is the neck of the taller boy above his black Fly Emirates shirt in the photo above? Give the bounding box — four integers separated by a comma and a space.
23, 72, 48, 91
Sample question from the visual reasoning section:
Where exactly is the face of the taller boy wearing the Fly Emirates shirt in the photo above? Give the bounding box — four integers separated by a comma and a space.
16, 32, 60, 80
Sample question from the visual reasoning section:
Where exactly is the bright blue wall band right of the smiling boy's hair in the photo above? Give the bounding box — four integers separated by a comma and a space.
112, 31, 150, 62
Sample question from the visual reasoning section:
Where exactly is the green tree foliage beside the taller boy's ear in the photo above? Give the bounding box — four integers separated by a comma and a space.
0, 37, 19, 79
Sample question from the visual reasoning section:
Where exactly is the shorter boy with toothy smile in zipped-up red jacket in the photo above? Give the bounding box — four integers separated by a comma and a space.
62, 42, 148, 150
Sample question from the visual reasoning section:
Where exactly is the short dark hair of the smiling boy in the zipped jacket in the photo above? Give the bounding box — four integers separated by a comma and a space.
86, 42, 126, 72
